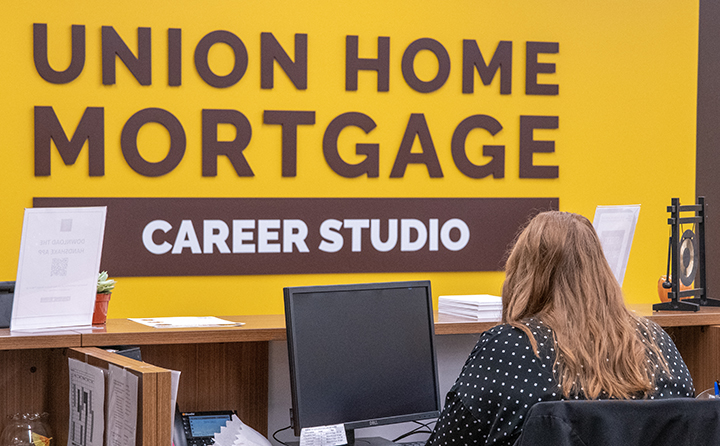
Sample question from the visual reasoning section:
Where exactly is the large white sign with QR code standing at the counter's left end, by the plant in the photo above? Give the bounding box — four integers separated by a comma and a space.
10, 206, 107, 330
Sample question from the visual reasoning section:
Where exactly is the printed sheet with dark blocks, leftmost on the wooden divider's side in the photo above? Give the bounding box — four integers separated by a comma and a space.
67, 358, 105, 446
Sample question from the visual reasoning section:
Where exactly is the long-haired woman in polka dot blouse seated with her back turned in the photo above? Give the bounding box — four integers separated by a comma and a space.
428, 211, 695, 446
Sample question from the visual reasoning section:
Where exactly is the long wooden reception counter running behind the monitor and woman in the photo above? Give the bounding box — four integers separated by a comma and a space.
0, 304, 720, 446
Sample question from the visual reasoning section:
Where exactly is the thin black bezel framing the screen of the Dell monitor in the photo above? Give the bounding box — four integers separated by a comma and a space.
283, 280, 442, 436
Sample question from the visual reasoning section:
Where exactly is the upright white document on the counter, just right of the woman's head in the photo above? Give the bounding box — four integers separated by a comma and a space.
593, 204, 640, 286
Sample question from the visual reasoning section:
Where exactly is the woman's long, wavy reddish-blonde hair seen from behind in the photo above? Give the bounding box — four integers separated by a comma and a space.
502, 211, 668, 399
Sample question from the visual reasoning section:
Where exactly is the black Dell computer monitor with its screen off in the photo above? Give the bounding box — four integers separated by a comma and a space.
284, 281, 442, 444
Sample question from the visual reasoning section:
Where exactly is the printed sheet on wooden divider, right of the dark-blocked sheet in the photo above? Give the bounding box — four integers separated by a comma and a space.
105, 364, 138, 446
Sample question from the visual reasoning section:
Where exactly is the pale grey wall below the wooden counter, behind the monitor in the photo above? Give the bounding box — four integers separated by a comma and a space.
268, 334, 480, 445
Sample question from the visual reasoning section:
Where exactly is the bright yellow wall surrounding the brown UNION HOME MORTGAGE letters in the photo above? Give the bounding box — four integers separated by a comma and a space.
0, 0, 698, 317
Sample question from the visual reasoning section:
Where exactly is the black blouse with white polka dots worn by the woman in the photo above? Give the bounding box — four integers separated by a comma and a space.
427, 319, 695, 446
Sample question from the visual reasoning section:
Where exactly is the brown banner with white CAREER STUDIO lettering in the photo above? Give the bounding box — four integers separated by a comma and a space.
33, 198, 559, 277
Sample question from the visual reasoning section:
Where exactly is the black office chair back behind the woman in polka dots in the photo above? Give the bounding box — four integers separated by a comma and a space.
515, 398, 720, 446
